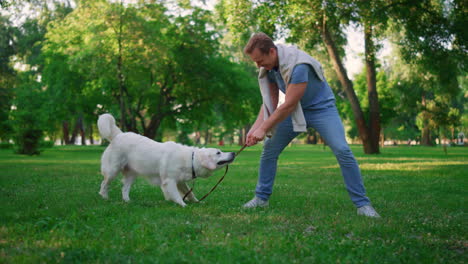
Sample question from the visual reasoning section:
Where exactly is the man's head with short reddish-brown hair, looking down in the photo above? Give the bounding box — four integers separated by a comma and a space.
244, 32, 278, 70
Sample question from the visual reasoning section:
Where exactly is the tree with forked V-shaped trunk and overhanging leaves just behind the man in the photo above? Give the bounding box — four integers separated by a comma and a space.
221, 0, 386, 154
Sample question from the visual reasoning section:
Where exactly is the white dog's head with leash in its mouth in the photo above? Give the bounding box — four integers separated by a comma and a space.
196, 148, 236, 177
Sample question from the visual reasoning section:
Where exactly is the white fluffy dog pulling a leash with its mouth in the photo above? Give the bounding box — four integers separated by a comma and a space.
98, 114, 235, 207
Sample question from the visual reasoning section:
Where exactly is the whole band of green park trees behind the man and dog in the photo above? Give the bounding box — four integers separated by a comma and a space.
0, 0, 467, 153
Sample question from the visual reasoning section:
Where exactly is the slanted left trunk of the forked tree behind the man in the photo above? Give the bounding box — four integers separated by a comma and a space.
321, 16, 374, 154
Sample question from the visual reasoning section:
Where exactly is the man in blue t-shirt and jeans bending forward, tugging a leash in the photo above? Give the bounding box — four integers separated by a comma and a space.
244, 33, 380, 217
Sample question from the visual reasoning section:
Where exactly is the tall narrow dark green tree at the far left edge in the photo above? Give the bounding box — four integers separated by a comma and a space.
1, 1, 73, 151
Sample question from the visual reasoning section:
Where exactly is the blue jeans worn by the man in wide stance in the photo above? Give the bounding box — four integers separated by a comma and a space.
255, 106, 370, 207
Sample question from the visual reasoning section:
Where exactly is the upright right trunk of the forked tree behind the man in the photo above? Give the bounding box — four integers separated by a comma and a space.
364, 23, 380, 154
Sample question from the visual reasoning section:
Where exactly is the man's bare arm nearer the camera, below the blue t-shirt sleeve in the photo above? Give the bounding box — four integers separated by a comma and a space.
252, 82, 307, 143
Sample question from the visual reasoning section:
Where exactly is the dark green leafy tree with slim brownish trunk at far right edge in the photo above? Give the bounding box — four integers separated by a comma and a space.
393, 1, 468, 145
